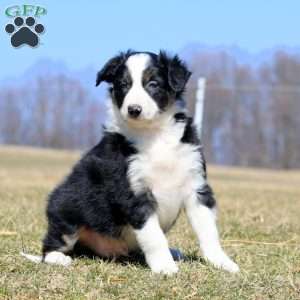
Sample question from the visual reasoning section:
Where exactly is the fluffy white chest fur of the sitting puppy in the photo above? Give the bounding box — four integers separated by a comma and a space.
128, 121, 201, 231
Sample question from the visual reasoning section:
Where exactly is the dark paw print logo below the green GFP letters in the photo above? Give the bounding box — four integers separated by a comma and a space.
5, 17, 45, 48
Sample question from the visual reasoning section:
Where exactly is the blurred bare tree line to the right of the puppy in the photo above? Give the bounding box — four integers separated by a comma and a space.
186, 52, 300, 169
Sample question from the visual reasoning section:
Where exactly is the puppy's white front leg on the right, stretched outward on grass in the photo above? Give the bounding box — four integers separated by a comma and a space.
185, 185, 239, 273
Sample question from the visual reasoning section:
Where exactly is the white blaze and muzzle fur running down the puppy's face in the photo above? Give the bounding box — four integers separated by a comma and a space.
121, 53, 159, 121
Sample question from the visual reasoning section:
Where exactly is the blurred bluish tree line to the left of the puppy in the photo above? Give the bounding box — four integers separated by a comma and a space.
0, 75, 105, 149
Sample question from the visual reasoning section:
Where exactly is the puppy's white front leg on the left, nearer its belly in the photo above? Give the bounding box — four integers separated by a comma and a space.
134, 213, 178, 275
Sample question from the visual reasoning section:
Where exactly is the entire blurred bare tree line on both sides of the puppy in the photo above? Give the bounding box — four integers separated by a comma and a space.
0, 52, 300, 168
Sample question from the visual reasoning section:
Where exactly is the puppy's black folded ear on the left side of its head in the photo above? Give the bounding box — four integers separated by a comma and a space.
96, 50, 130, 86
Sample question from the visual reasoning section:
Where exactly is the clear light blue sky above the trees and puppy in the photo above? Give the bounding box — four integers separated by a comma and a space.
0, 0, 300, 79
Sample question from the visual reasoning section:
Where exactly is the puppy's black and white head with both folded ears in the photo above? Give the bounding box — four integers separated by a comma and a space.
96, 51, 191, 125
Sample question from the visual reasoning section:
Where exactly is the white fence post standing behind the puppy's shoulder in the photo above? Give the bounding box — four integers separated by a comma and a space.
194, 77, 206, 138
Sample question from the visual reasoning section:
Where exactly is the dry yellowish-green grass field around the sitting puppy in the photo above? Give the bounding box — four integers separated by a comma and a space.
0, 147, 300, 299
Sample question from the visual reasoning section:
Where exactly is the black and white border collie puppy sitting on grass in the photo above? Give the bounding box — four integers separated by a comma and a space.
23, 51, 239, 274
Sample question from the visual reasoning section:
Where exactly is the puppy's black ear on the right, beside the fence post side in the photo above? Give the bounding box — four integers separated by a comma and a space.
159, 51, 192, 94
